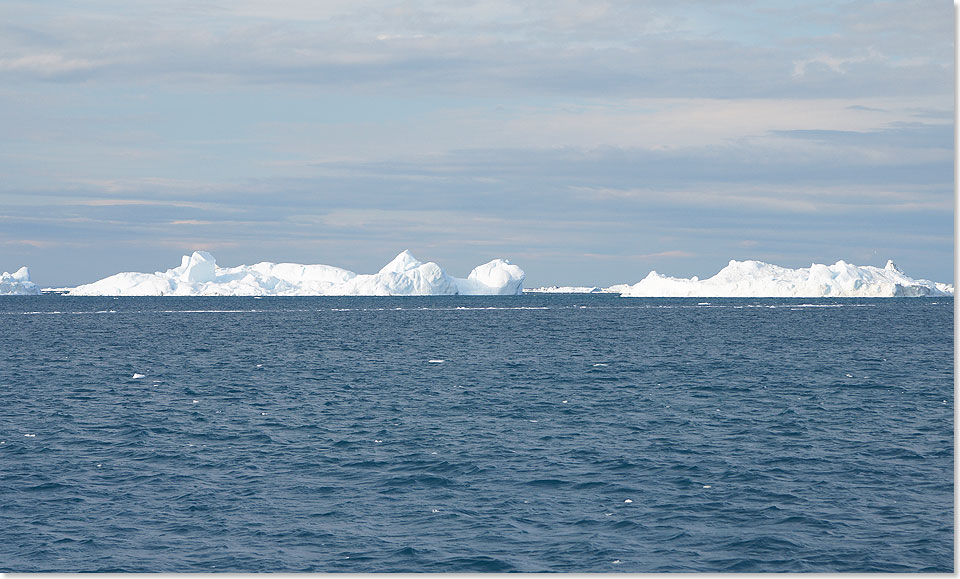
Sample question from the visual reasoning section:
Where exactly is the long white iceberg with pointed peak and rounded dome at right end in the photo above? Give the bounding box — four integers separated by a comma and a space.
68, 251, 525, 296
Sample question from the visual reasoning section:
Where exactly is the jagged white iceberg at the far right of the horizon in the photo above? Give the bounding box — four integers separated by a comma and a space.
607, 260, 953, 298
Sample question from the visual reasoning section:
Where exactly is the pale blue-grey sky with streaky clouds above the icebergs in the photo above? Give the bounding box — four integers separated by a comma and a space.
0, 0, 955, 287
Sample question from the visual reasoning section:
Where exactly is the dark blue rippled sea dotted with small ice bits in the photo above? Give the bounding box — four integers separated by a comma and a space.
0, 295, 954, 572
